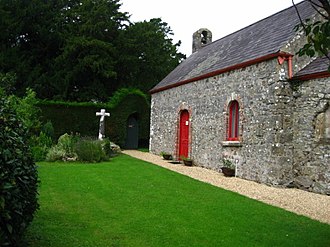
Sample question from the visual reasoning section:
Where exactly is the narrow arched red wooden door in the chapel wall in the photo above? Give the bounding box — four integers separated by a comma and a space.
179, 110, 190, 158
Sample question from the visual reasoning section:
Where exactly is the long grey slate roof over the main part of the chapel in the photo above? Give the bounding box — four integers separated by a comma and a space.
150, 1, 315, 93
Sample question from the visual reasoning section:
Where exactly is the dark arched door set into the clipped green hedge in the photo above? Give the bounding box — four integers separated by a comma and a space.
125, 114, 139, 149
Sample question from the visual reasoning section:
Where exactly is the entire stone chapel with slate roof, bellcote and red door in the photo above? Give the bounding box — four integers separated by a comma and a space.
150, 1, 330, 195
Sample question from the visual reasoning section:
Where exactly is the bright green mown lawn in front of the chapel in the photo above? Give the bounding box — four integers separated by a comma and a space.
27, 155, 330, 247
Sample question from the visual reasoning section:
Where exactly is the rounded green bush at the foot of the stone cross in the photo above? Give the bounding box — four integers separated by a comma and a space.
75, 139, 108, 162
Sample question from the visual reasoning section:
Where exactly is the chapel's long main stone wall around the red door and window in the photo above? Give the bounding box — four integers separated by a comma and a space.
150, 59, 293, 185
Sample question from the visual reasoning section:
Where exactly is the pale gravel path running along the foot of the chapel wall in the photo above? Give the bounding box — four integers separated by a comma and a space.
123, 150, 330, 224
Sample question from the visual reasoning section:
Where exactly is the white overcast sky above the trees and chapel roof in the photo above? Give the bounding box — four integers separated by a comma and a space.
120, 0, 302, 56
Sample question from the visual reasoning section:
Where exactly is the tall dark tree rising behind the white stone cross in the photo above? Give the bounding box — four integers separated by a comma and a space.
45, 0, 128, 101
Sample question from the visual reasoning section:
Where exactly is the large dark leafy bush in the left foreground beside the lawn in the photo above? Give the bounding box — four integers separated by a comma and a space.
0, 97, 38, 246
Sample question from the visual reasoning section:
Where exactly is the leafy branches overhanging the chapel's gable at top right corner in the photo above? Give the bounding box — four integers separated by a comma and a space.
292, 0, 330, 71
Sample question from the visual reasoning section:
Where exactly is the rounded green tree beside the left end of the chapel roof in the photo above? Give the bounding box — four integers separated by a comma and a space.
117, 18, 185, 92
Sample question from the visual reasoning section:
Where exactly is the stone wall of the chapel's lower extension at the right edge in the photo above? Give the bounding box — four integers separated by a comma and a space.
293, 78, 330, 195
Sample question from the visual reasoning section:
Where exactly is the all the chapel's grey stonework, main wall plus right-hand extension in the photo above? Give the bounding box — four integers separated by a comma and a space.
150, 59, 330, 194
